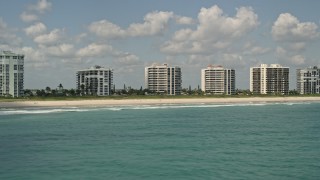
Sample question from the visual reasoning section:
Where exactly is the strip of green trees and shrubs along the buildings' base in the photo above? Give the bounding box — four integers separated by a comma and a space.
0, 84, 320, 102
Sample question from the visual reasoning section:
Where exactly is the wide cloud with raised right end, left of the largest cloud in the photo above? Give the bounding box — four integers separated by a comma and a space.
88, 11, 173, 38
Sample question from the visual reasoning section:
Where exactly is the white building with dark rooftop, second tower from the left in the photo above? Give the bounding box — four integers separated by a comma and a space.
77, 66, 113, 96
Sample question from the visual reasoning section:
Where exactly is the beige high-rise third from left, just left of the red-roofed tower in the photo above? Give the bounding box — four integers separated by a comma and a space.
145, 64, 182, 95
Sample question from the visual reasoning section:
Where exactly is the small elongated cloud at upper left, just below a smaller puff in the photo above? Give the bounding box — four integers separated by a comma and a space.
34, 29, 64, 45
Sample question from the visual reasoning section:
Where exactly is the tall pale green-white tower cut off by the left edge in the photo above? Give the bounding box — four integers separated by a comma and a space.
0, 51, 24, 97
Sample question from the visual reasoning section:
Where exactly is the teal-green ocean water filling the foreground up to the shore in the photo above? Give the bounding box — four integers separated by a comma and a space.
0, 103, 320, 180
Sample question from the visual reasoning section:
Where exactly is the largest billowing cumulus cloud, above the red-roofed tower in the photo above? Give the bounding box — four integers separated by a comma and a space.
161, 5, 259, 54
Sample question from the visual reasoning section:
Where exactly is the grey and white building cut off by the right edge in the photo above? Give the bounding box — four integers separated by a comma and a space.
297, 66, 320, 94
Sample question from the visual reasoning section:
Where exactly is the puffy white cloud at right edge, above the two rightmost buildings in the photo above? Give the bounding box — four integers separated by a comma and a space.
271, 13, 319, 42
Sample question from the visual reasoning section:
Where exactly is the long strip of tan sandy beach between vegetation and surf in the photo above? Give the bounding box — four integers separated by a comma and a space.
0, 97, 320, 108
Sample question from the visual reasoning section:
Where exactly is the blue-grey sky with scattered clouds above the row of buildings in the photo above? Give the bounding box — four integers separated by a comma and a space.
0, 0, 320, 89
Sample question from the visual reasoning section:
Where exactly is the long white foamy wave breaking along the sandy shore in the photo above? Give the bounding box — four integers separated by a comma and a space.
0, 102, 310, 116
